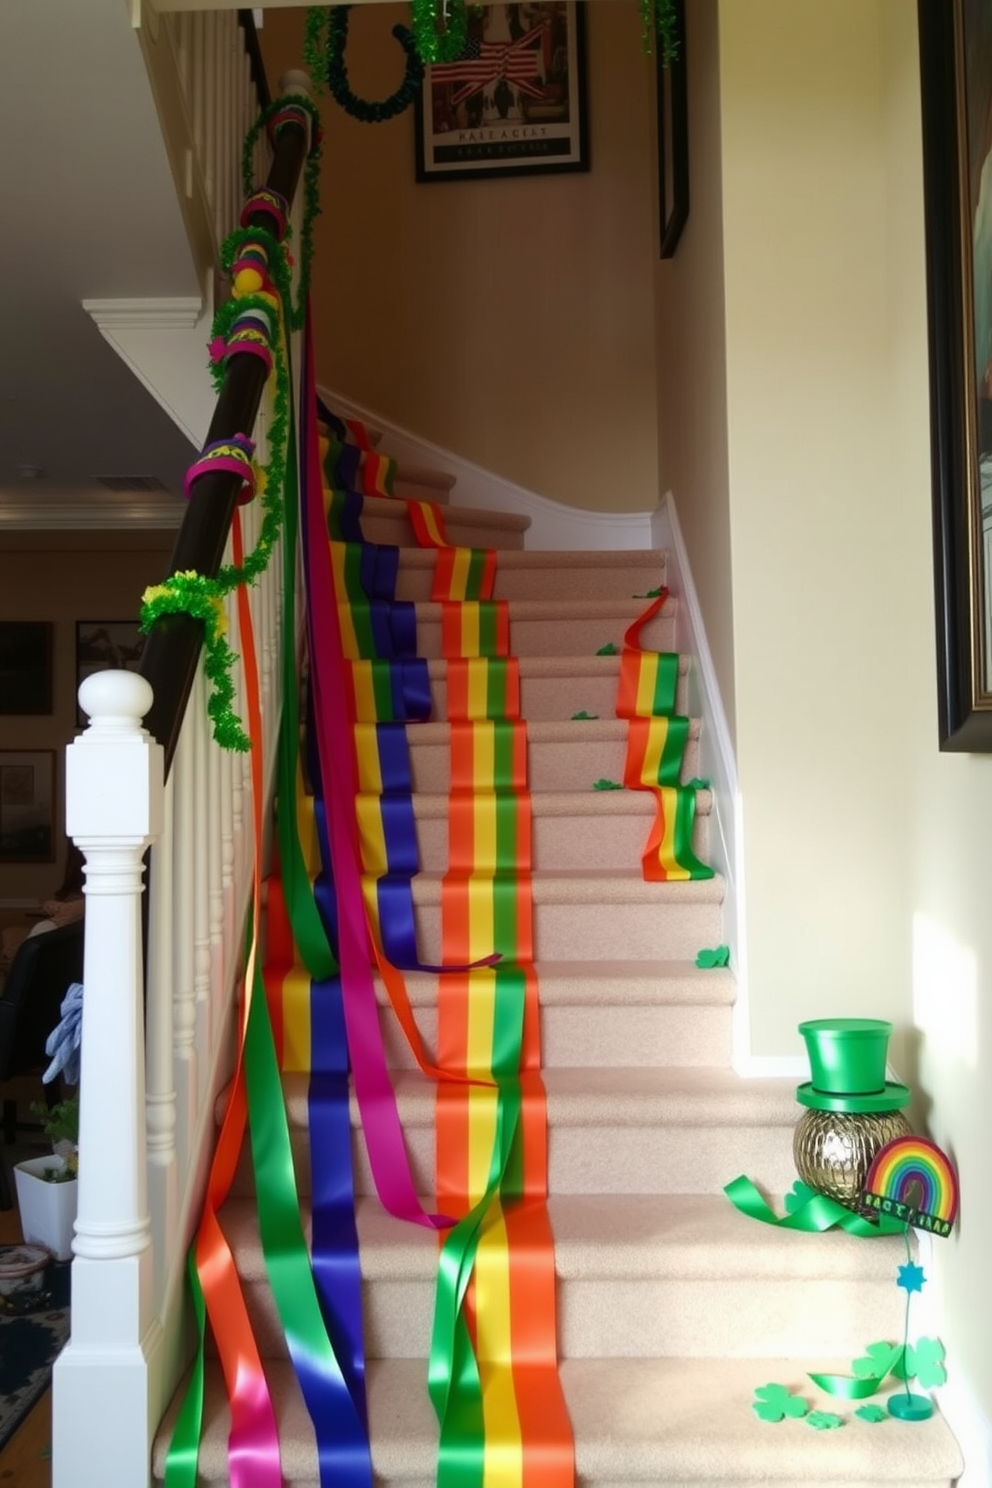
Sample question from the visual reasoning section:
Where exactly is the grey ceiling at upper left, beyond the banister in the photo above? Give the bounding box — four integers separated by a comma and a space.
0, 0, 201, 535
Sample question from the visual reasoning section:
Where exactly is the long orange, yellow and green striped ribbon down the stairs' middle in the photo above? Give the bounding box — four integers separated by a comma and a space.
430, 556, 574, 1488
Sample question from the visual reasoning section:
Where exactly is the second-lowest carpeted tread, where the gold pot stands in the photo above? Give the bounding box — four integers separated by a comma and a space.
222, 1193, 904, 1287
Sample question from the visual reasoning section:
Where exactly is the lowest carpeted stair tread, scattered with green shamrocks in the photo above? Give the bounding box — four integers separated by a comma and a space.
161, 1359, 962, 1488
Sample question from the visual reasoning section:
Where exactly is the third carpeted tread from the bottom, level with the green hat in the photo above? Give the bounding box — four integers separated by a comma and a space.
272, 1065, 797, 1130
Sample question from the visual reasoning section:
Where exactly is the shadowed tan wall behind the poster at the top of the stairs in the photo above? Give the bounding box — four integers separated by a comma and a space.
262, 0, 657, 510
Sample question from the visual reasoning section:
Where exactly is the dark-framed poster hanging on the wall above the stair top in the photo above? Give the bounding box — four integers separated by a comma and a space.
415, 0, 589, 182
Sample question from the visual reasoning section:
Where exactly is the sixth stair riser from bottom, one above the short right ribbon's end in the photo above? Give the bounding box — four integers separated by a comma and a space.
408, 729, 699, 795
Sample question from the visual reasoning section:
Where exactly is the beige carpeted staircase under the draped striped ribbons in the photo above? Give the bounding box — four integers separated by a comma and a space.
155, 434, 961, 1488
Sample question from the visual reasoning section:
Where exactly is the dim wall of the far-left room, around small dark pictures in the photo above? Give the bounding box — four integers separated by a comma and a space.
0, 531, 173, 900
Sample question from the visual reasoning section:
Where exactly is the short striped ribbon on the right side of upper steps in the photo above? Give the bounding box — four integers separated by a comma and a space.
616, 589, 712, 882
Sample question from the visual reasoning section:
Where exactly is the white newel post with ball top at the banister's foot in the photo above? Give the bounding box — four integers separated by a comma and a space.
52, 671, 164, 1488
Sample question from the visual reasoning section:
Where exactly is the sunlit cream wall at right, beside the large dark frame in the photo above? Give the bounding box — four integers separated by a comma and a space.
687, 0, 992, 1417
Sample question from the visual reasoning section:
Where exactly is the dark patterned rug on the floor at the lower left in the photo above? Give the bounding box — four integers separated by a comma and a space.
0, 1263, 70, 1449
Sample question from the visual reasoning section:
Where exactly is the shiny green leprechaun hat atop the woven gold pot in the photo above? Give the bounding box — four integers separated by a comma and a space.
796, 1018, 910, 1112
